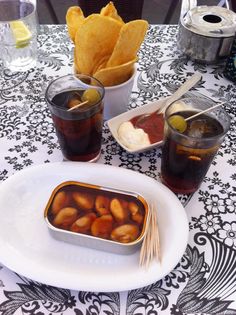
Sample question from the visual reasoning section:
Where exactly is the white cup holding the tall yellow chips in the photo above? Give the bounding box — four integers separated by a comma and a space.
104, 68, 137, 120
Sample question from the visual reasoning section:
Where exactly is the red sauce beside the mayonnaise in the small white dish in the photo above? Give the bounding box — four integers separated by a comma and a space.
130, 113, 164, 143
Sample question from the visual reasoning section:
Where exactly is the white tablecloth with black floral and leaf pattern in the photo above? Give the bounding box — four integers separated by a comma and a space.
0, 25, 236, 315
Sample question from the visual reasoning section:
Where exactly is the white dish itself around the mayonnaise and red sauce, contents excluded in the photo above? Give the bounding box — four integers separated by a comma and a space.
107, 98, 168, 153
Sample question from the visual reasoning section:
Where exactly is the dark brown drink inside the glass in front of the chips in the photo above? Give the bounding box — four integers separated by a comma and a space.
51, 90, 103, 161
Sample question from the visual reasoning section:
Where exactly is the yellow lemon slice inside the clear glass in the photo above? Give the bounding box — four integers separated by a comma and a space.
10, 21, 32, 48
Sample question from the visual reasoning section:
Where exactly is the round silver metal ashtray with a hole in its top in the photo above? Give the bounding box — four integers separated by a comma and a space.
177, 6, 236, 63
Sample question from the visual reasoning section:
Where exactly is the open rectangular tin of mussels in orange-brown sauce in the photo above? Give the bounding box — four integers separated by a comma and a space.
44, 181, 148, 254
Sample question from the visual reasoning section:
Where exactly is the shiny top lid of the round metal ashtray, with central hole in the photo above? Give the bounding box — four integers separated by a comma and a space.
181, 6, 236, 37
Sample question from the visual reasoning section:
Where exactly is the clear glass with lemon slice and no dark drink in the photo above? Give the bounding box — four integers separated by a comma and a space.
0, 0, 38, 71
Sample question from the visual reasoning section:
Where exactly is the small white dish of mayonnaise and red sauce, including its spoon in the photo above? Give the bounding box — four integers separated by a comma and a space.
108, 73, 201, 153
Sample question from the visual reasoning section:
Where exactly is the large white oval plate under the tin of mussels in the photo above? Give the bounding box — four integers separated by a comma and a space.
0, 162, 188, 292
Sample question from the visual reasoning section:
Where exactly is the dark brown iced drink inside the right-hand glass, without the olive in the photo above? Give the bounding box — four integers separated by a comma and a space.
161, 110, 224, 193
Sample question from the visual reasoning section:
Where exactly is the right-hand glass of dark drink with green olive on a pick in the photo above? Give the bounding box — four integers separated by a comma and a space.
161, 98, 230, 194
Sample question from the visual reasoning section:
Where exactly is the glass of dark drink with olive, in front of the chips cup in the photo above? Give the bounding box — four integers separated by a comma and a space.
45, 74, 104, 162
